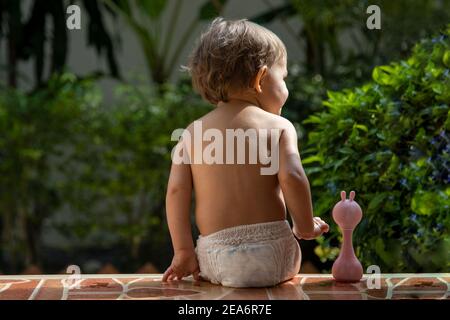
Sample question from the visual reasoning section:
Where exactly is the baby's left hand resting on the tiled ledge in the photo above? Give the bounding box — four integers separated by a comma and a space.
162, 251, 200, 282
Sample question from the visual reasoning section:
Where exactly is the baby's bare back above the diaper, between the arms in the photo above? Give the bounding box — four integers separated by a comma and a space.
188, 105, 286, 235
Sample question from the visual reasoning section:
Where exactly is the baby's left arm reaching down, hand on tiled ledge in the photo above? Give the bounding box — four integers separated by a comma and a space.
163, 139, 199, 281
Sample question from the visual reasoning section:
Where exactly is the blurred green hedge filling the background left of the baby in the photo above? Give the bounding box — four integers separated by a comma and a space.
0, 74, 211, 273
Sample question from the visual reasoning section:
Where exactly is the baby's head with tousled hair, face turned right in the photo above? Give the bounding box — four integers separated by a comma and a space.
188, 18, 288, 114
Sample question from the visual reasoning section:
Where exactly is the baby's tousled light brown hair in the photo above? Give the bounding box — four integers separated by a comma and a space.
185, 17, 287, 104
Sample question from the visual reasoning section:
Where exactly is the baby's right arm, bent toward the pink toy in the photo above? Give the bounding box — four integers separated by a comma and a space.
278, 119, 329, 240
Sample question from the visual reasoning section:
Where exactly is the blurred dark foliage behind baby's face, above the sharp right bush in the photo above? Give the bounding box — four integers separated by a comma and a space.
270, 0, 450, 142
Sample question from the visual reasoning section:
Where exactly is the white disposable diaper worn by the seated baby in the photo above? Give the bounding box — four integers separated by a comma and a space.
195, 220, 301, 287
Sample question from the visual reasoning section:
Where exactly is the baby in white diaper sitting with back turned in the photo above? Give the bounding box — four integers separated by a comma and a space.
163, 18, 329, 287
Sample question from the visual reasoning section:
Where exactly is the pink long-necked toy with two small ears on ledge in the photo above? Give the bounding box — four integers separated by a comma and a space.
332, 191, 363, 282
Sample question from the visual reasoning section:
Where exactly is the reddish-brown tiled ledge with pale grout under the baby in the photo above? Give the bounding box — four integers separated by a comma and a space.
0, 273, 450, 300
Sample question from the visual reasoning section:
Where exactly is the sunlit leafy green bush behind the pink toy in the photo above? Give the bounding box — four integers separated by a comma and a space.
302, 26, 450, 273
